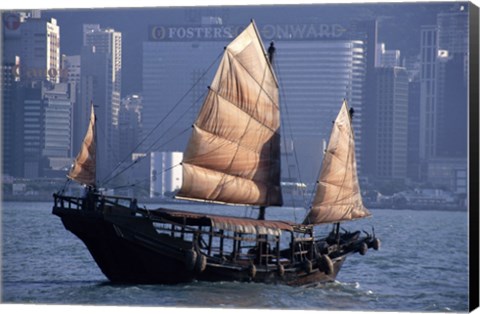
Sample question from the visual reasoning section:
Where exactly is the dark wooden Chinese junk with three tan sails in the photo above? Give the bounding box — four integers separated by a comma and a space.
53, 22, 380, 285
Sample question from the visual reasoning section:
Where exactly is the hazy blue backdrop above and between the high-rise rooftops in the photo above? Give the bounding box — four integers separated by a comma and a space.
37, 2, 452, 95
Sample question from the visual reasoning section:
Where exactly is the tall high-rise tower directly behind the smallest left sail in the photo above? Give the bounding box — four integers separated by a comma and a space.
80, 25, 122, 180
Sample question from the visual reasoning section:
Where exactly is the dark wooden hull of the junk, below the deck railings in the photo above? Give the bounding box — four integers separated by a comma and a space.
53, 202, 346, 285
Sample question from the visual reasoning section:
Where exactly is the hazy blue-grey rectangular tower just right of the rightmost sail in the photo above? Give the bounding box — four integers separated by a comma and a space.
374, 67, 408, 180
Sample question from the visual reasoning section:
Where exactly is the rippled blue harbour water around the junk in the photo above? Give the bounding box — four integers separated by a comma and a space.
2, 202, 468, 312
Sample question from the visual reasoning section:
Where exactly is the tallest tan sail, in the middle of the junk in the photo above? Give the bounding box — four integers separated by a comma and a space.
177, 22, 282, 206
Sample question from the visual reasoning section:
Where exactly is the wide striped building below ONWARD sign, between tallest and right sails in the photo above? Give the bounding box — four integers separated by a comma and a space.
275, 40, 366, 182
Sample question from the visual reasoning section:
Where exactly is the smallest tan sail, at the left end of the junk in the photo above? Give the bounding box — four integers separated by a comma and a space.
67, 104, 96, 186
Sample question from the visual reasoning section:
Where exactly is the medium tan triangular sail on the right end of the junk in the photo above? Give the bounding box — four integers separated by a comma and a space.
304, 101, 370, 224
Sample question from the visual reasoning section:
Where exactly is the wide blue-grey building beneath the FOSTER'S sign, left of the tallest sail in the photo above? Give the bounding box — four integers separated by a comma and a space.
142, 41, 225, 152
